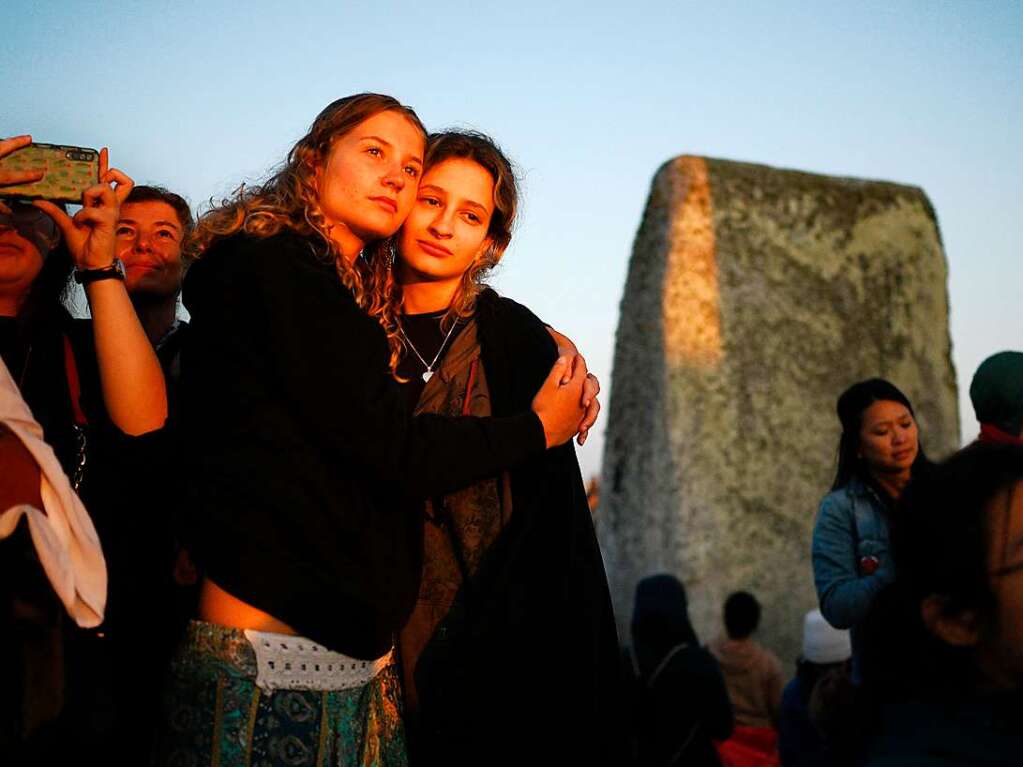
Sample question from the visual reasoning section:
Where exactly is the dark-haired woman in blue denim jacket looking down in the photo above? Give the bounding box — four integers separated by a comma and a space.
813, 378, 928, 683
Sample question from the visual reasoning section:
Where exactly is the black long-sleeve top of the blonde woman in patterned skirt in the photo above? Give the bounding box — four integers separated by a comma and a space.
181, 233, 544, 658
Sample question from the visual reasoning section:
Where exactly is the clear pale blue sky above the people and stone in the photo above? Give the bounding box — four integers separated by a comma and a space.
0, 0, 1023, 476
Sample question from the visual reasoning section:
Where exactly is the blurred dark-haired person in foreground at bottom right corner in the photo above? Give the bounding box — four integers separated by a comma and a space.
864, 442, 1023, 767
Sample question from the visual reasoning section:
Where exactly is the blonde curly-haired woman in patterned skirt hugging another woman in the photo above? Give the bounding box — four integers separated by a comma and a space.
157, 94, 597, 765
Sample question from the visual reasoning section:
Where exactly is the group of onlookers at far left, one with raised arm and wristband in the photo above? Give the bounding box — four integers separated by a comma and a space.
0, 134, 197, 764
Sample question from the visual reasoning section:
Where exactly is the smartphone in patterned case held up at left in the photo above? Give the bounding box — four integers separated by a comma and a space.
0, 143, 99, 202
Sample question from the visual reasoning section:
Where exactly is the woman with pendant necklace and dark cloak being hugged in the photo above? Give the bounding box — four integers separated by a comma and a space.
373, 131, 625, 765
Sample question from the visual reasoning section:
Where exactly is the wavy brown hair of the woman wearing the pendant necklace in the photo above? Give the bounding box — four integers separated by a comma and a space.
367, 130, 519, 371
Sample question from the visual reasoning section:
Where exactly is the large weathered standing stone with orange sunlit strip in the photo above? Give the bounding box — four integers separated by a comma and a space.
597, 156, 959, 664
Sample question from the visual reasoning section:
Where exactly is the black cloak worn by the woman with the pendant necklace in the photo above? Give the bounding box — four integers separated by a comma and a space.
411, 290, 626, 765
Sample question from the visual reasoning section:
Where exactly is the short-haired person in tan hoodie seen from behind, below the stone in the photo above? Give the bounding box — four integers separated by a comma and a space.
710, 591, 784, 728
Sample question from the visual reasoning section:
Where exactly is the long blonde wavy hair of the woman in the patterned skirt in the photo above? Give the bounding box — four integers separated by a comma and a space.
189, 93, 427, 308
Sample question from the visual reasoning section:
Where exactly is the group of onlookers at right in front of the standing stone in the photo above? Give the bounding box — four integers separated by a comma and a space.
628, 352, 1023, 767
